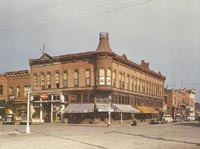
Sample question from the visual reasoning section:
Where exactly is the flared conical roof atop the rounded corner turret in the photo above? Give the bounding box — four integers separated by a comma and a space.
96, 32, 113, 53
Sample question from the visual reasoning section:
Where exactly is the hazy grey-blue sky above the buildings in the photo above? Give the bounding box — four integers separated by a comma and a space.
0, 0, 200, 101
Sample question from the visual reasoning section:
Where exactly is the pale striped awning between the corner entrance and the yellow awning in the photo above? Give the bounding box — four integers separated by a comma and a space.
112, 104, 140, 113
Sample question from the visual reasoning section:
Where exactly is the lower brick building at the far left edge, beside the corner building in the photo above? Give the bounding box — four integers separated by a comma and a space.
0, 70, 30, 116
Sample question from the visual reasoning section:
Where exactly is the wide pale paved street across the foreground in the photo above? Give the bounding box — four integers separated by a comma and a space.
0, 122, 200, 149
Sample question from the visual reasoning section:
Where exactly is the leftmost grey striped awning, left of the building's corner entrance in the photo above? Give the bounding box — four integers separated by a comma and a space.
63, 103, 94, 113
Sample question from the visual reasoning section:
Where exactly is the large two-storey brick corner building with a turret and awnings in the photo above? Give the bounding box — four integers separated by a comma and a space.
29, 33, 165, 122
